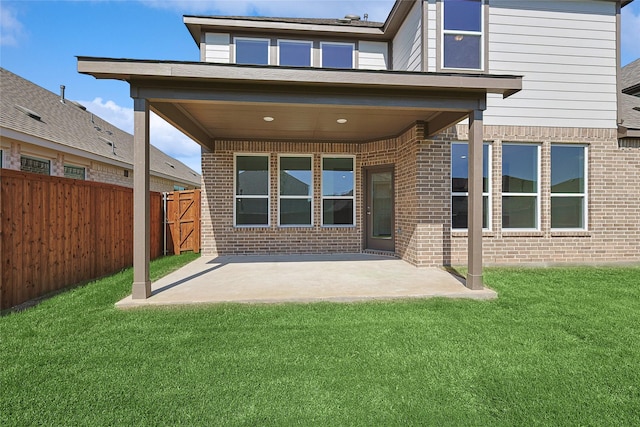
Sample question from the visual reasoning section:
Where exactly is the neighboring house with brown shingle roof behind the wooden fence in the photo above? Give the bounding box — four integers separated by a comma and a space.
0, 68, 200, 192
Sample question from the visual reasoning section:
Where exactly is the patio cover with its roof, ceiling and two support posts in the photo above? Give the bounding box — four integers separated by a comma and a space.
78, 57, 522, 300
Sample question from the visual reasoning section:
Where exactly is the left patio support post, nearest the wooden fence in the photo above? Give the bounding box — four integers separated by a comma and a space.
131, 98, 151, 299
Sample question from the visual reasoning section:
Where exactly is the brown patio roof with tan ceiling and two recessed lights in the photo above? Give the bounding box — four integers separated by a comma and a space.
78, 57, 521, 149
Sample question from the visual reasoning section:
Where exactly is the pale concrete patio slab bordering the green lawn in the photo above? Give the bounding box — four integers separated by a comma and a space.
116, 254, 497, 308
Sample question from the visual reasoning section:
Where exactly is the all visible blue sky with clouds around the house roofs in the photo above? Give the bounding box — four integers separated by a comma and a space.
0, 0, 640, 172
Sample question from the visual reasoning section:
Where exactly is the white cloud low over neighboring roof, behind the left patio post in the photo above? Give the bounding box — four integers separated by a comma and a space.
79, 98, 201, 173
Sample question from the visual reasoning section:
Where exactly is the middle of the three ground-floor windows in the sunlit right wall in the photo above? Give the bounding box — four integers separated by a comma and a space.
502, 144, 540, 230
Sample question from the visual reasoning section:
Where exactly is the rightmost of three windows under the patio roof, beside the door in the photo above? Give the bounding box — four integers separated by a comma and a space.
322, 157, 356, 225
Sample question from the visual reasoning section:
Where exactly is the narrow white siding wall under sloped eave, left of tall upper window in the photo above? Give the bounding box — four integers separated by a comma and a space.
393, 2, 423, 71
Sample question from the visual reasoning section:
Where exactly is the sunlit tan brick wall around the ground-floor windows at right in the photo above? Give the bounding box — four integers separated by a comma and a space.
446, 126, 640, 265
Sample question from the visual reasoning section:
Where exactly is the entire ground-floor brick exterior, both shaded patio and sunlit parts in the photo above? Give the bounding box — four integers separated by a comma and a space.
202, 123, 640, 266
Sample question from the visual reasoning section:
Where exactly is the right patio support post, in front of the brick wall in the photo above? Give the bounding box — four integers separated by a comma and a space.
467, 110, 483, 290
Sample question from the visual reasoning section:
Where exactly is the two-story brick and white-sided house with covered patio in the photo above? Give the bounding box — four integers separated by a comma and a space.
78, 0, 640, 298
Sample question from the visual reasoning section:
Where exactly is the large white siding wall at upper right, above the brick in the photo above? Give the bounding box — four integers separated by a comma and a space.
485, 0, 617, 129
